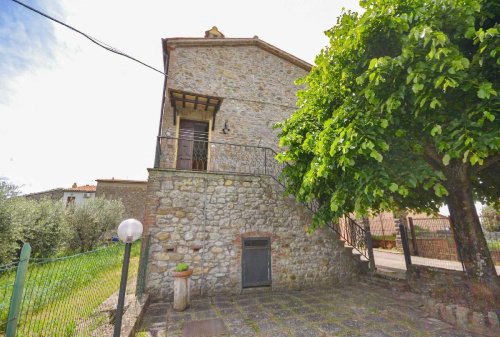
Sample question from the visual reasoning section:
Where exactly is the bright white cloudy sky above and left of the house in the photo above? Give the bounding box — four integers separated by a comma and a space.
0, 0, 357, 192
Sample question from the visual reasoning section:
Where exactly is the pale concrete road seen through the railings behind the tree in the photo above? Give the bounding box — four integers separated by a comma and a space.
373, 249, 500, 275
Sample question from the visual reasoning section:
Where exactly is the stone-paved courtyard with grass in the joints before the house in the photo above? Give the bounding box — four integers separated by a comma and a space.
139, 283, 484, 337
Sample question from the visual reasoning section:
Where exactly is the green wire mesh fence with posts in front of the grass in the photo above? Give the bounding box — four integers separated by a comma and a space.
0, 243, 146, 337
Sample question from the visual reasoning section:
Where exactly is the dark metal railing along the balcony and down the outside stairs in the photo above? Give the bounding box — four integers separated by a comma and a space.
155, 135, 375, 270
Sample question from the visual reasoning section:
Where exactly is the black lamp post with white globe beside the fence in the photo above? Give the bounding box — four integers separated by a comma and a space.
113, 219, 142, 337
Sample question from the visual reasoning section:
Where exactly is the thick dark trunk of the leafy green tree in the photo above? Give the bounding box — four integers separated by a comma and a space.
444, 162, 500, 299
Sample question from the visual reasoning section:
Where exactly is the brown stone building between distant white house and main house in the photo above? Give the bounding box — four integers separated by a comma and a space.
96, 178, 148, 222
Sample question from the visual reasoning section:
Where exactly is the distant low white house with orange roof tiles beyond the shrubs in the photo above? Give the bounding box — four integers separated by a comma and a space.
24, 183, 96, 205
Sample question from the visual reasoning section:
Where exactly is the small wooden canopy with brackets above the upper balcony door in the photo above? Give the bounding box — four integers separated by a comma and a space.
168, 88, 222, 130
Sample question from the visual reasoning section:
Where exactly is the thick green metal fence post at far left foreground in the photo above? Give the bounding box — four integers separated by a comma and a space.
5, 243, 31, 337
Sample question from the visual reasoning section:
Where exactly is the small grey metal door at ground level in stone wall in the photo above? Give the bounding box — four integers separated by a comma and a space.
242, 238, 271, 288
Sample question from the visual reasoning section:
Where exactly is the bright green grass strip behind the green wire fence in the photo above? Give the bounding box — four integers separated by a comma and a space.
0, 243, 140, 337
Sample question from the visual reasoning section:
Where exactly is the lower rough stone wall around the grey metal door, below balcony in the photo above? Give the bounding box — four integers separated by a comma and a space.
145, 169, 361, 300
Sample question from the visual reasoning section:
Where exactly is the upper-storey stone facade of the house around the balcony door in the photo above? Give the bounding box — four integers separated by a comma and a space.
160, 42, 307, 170
